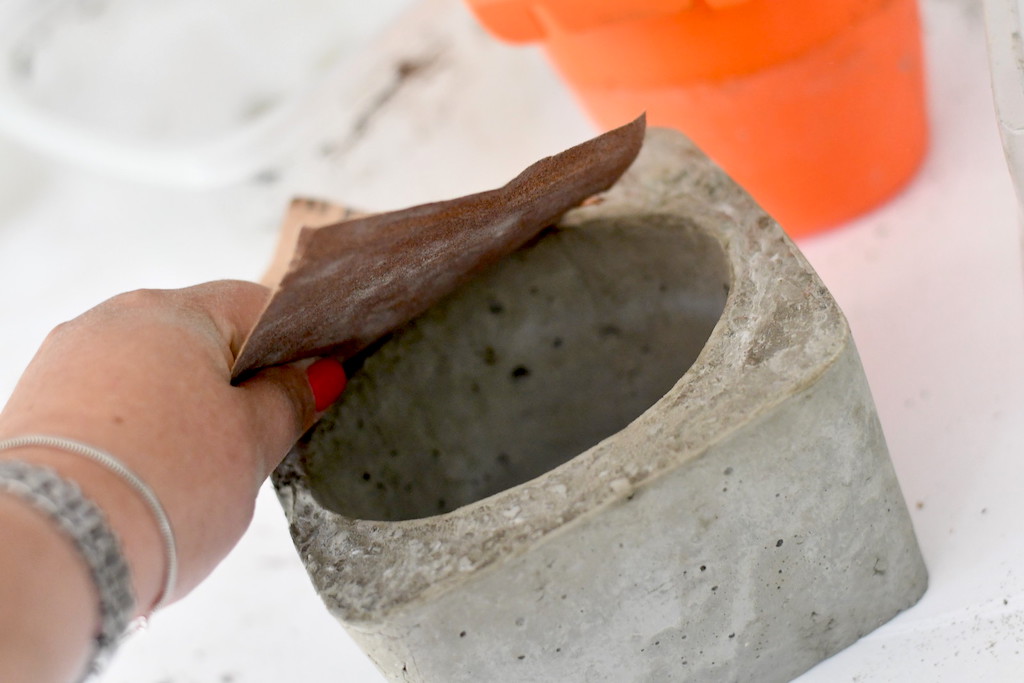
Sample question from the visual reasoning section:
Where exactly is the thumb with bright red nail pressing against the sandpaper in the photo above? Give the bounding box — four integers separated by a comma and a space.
238, 358, 347, 475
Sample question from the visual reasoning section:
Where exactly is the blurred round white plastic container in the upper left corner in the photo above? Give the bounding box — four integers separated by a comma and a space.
0, 0, 410, 187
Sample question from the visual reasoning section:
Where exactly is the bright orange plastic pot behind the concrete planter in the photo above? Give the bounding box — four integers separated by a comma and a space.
467, 0, 928, 237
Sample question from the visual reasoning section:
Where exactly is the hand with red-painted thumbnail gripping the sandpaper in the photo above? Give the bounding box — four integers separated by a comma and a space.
0, 282, 342, 612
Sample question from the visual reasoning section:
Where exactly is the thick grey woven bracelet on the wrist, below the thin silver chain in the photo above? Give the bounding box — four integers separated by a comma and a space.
0, 460, 135, 680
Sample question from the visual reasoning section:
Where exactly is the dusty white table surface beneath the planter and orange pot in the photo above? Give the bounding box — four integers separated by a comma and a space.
0, 0, 1024, 683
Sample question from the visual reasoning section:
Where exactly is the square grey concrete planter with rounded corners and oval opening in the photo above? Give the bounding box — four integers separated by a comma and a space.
274, 126, 927, 683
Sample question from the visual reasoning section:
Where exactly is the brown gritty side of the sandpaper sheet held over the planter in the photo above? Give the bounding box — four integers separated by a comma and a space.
231, 111, 645, 379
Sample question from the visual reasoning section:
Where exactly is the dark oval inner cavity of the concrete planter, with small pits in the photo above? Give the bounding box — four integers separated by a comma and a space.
303, 214, 729, 520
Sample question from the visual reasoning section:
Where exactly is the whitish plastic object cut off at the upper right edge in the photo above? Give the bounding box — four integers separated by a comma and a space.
985, 0, 1024, 206
